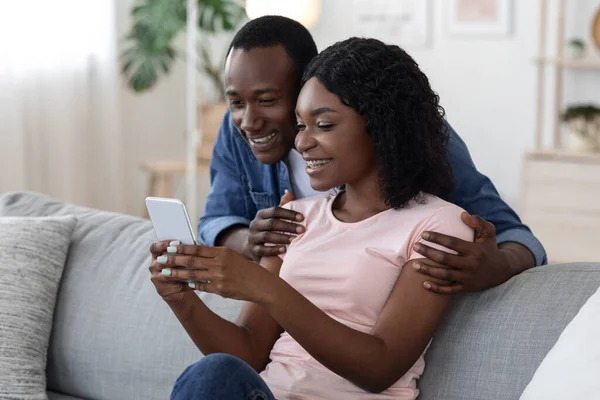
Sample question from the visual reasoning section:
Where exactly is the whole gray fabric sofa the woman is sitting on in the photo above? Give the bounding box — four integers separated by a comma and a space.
0, 193, 600, 400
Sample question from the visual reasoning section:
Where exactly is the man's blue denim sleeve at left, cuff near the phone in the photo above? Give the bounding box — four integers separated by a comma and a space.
198, 110, 253, 246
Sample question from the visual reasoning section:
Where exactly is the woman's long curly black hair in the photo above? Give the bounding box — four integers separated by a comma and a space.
302, 38, 452, 208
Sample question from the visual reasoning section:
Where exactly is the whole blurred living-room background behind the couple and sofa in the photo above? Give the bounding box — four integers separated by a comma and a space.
0, 0, 600, 262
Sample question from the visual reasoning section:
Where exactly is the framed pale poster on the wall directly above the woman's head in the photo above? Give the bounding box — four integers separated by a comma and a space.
352, 0, 431, 48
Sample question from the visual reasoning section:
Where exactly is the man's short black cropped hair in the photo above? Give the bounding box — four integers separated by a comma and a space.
228, 15, 318, 79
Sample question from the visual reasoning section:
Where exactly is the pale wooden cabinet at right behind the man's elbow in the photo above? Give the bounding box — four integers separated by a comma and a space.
519, 151, 600, 263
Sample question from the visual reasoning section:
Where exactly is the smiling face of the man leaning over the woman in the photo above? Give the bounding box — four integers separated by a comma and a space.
225, 46, 298, 164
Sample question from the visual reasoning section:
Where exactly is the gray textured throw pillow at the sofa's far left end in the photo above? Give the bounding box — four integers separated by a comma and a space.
0, 216, 76, 400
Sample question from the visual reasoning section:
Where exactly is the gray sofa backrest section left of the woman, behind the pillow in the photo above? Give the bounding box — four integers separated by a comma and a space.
0, 192, 241, 400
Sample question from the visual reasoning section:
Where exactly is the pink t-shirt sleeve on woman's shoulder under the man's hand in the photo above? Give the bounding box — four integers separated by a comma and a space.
407, 204, 475, 260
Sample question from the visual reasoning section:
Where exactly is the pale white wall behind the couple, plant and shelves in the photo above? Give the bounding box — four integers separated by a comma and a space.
117, 0, 600, 214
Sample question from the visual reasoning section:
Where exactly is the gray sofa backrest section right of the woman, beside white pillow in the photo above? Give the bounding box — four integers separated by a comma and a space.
419, 263, 600, 400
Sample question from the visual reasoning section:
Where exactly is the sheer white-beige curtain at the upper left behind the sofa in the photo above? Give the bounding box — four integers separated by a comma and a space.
0, 0, 125, 211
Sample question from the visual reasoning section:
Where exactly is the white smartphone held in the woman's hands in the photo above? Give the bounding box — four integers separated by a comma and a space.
146, 197, 198, 244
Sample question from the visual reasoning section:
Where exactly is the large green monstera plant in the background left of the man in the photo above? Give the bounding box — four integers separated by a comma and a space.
121, 0, 246, 152
